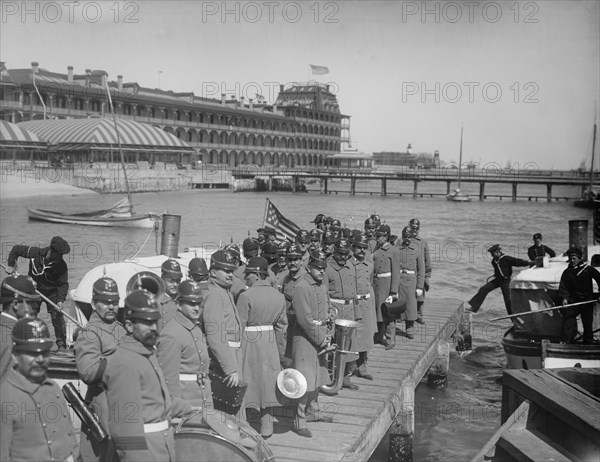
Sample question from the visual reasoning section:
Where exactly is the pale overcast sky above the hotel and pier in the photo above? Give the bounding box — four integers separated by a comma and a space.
0, 0, 600, 169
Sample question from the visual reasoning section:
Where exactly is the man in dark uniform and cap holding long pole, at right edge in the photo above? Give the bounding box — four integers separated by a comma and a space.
558, 247, 600, 345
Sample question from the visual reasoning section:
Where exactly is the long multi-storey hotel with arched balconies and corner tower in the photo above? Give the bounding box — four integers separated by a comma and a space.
0, 62, 350, 167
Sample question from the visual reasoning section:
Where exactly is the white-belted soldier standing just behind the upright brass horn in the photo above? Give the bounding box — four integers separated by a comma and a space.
323, 238, 359, 390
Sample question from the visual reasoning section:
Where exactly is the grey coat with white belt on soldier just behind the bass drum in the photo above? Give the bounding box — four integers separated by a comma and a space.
157, 311, 213, 409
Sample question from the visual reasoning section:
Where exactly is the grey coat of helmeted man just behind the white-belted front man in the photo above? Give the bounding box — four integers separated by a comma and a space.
74, 311, 127, 461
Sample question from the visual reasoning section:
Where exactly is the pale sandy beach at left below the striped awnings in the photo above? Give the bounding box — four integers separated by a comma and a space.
0, 174, 99, 200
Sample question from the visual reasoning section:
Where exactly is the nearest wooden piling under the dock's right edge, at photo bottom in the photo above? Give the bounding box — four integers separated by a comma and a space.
388, 380, 415, 462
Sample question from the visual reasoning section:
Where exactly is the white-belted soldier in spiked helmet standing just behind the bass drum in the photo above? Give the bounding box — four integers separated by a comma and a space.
157, 281, 213, 410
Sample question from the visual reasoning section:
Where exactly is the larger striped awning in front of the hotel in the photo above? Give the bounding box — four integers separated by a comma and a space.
18, 117, 195, 152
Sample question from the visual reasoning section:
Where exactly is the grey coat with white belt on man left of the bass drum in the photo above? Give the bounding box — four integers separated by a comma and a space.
104, 335, 191, 462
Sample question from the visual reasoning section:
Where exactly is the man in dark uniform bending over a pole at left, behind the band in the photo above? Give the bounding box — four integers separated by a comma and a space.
6, 236, 71, 352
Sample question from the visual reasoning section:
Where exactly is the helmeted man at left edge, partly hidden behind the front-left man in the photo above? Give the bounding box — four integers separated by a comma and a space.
0, 275, 41, 382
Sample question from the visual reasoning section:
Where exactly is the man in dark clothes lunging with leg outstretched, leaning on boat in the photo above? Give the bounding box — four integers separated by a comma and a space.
468, 244, 533, 314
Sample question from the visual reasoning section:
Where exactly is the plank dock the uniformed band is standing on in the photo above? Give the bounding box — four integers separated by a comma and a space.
260, 299, 463, 462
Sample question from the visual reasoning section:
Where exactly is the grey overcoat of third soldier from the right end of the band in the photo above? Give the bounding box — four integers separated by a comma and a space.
373, 242, 400, 322
